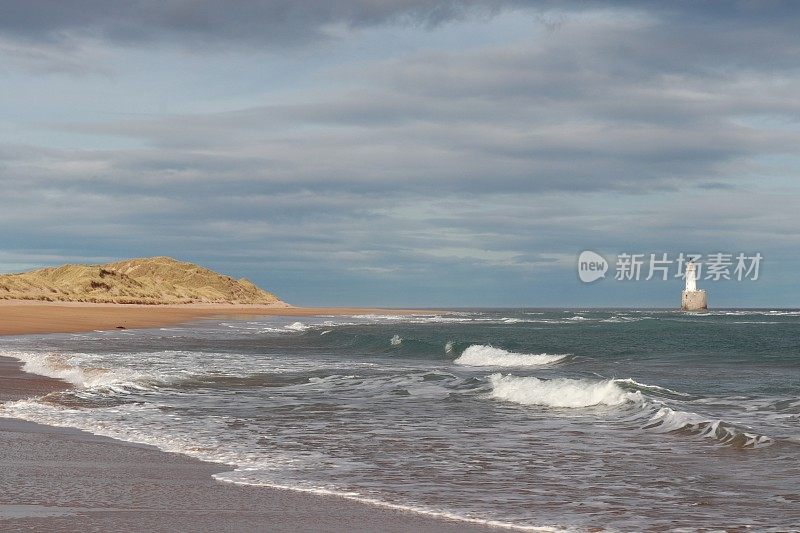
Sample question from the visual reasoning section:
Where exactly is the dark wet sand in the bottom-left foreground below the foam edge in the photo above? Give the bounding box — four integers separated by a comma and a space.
0, 418, 496, 533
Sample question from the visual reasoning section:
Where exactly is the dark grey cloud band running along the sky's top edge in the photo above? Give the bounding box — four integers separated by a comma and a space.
0, 0, 800, 50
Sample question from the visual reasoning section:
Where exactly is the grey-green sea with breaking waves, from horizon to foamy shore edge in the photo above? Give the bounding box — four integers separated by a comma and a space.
0, 309, 800, 531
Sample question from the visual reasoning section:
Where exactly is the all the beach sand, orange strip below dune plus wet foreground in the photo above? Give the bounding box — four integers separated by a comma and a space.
0, 302, 495, 532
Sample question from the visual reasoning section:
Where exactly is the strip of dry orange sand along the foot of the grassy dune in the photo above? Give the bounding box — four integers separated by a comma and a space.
0, 300, 435, 335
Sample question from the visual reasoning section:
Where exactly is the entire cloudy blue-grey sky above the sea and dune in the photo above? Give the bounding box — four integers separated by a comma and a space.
0, 0, 800, 308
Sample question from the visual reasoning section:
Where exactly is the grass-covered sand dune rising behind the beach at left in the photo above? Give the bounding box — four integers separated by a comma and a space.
0, 257, 285, 305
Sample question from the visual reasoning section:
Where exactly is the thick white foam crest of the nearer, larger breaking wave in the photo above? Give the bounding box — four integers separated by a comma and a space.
489, 374, 644, 408
